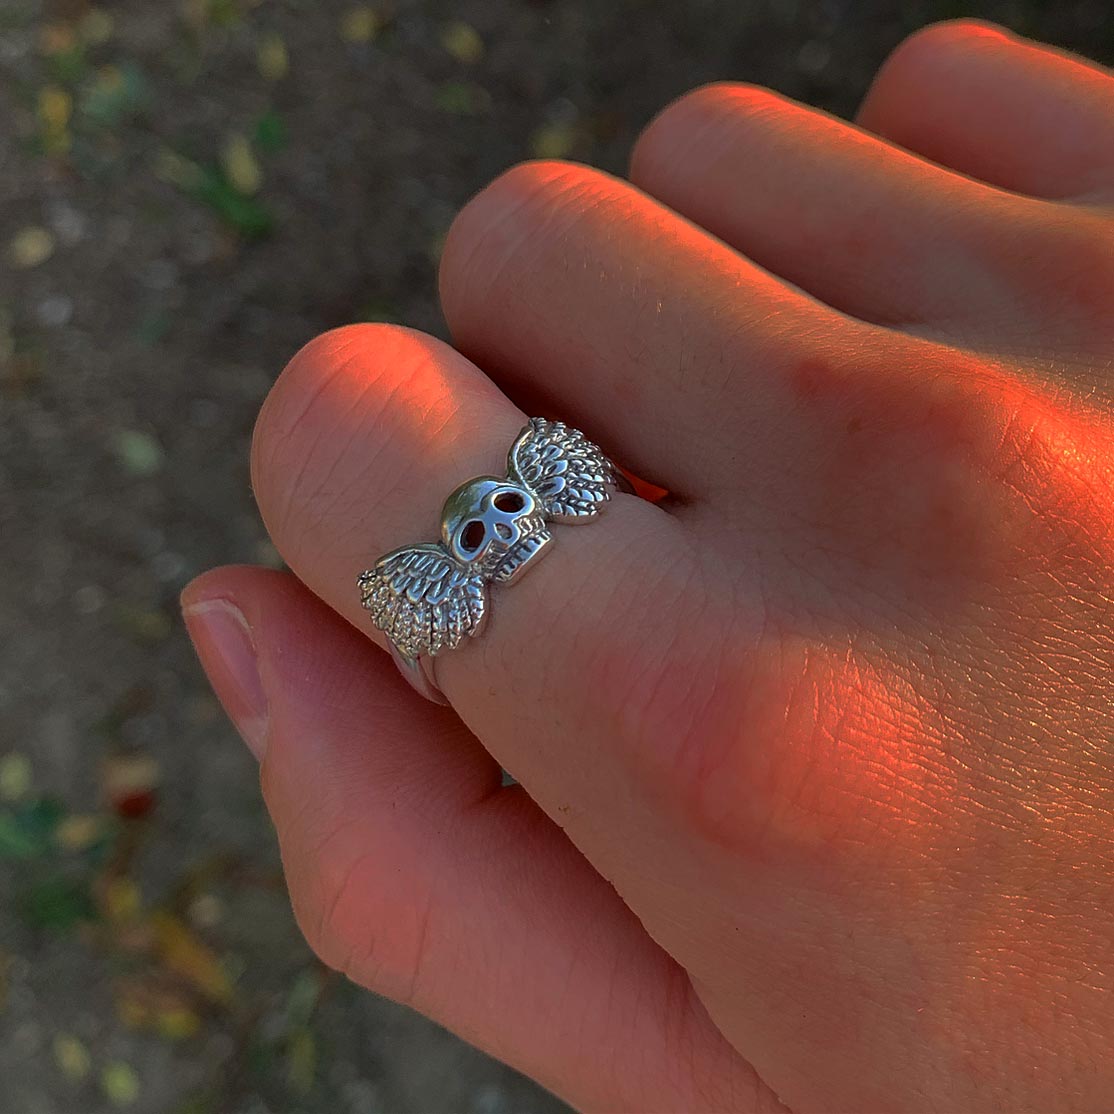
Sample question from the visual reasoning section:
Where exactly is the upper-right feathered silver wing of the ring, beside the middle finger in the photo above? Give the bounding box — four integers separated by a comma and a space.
508, 418, 615, 519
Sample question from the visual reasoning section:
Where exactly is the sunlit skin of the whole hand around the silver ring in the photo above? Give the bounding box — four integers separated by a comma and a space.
183, 21, 1114, 1112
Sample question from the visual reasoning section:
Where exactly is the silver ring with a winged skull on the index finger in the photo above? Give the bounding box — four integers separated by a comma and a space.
356, 418, 631, 704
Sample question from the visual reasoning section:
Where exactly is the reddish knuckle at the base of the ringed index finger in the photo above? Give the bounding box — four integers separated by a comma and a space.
628, 603, 946, 868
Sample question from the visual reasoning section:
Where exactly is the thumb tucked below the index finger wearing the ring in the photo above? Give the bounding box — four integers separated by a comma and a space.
183, 568, 776, 1111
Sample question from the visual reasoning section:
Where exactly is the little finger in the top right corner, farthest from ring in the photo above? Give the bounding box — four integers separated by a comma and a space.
858, 20, 1114, 198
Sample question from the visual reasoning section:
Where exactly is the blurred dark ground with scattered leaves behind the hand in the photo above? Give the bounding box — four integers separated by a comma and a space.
0, 0, 1114, 1114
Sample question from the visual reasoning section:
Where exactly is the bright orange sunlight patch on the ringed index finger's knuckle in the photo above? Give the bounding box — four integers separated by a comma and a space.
682, 637, 956, 867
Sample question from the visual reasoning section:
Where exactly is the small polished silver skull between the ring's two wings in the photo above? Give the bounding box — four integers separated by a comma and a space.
441, 476, 553, 583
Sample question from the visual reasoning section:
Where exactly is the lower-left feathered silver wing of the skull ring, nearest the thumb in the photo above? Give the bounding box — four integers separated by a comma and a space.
358, 545, 487, 657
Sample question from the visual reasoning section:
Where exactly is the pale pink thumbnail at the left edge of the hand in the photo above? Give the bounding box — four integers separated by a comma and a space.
182, 598, 267, 762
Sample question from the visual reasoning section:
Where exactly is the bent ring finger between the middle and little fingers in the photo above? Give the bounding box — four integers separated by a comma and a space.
631, 84, 1012, 324
